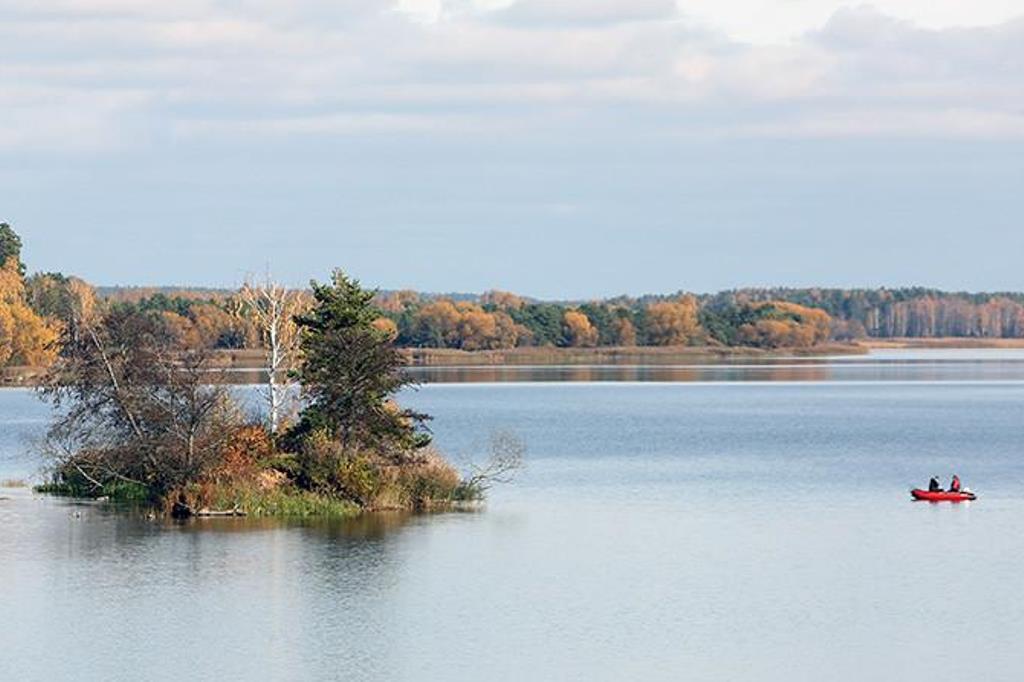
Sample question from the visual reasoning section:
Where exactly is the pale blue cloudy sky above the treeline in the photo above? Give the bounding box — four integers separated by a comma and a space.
0, 0, 1024, 299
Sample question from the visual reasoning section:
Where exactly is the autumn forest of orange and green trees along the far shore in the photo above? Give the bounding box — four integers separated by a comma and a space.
6, 223, 1024, 367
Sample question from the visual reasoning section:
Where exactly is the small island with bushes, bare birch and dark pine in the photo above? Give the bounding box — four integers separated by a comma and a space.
39, 270, 520, 517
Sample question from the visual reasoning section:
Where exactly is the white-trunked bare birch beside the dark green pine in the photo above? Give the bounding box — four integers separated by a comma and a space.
239, 275, 306, 433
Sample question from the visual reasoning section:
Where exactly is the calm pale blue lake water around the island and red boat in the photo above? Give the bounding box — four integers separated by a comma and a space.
0, 351, 1024, 680
